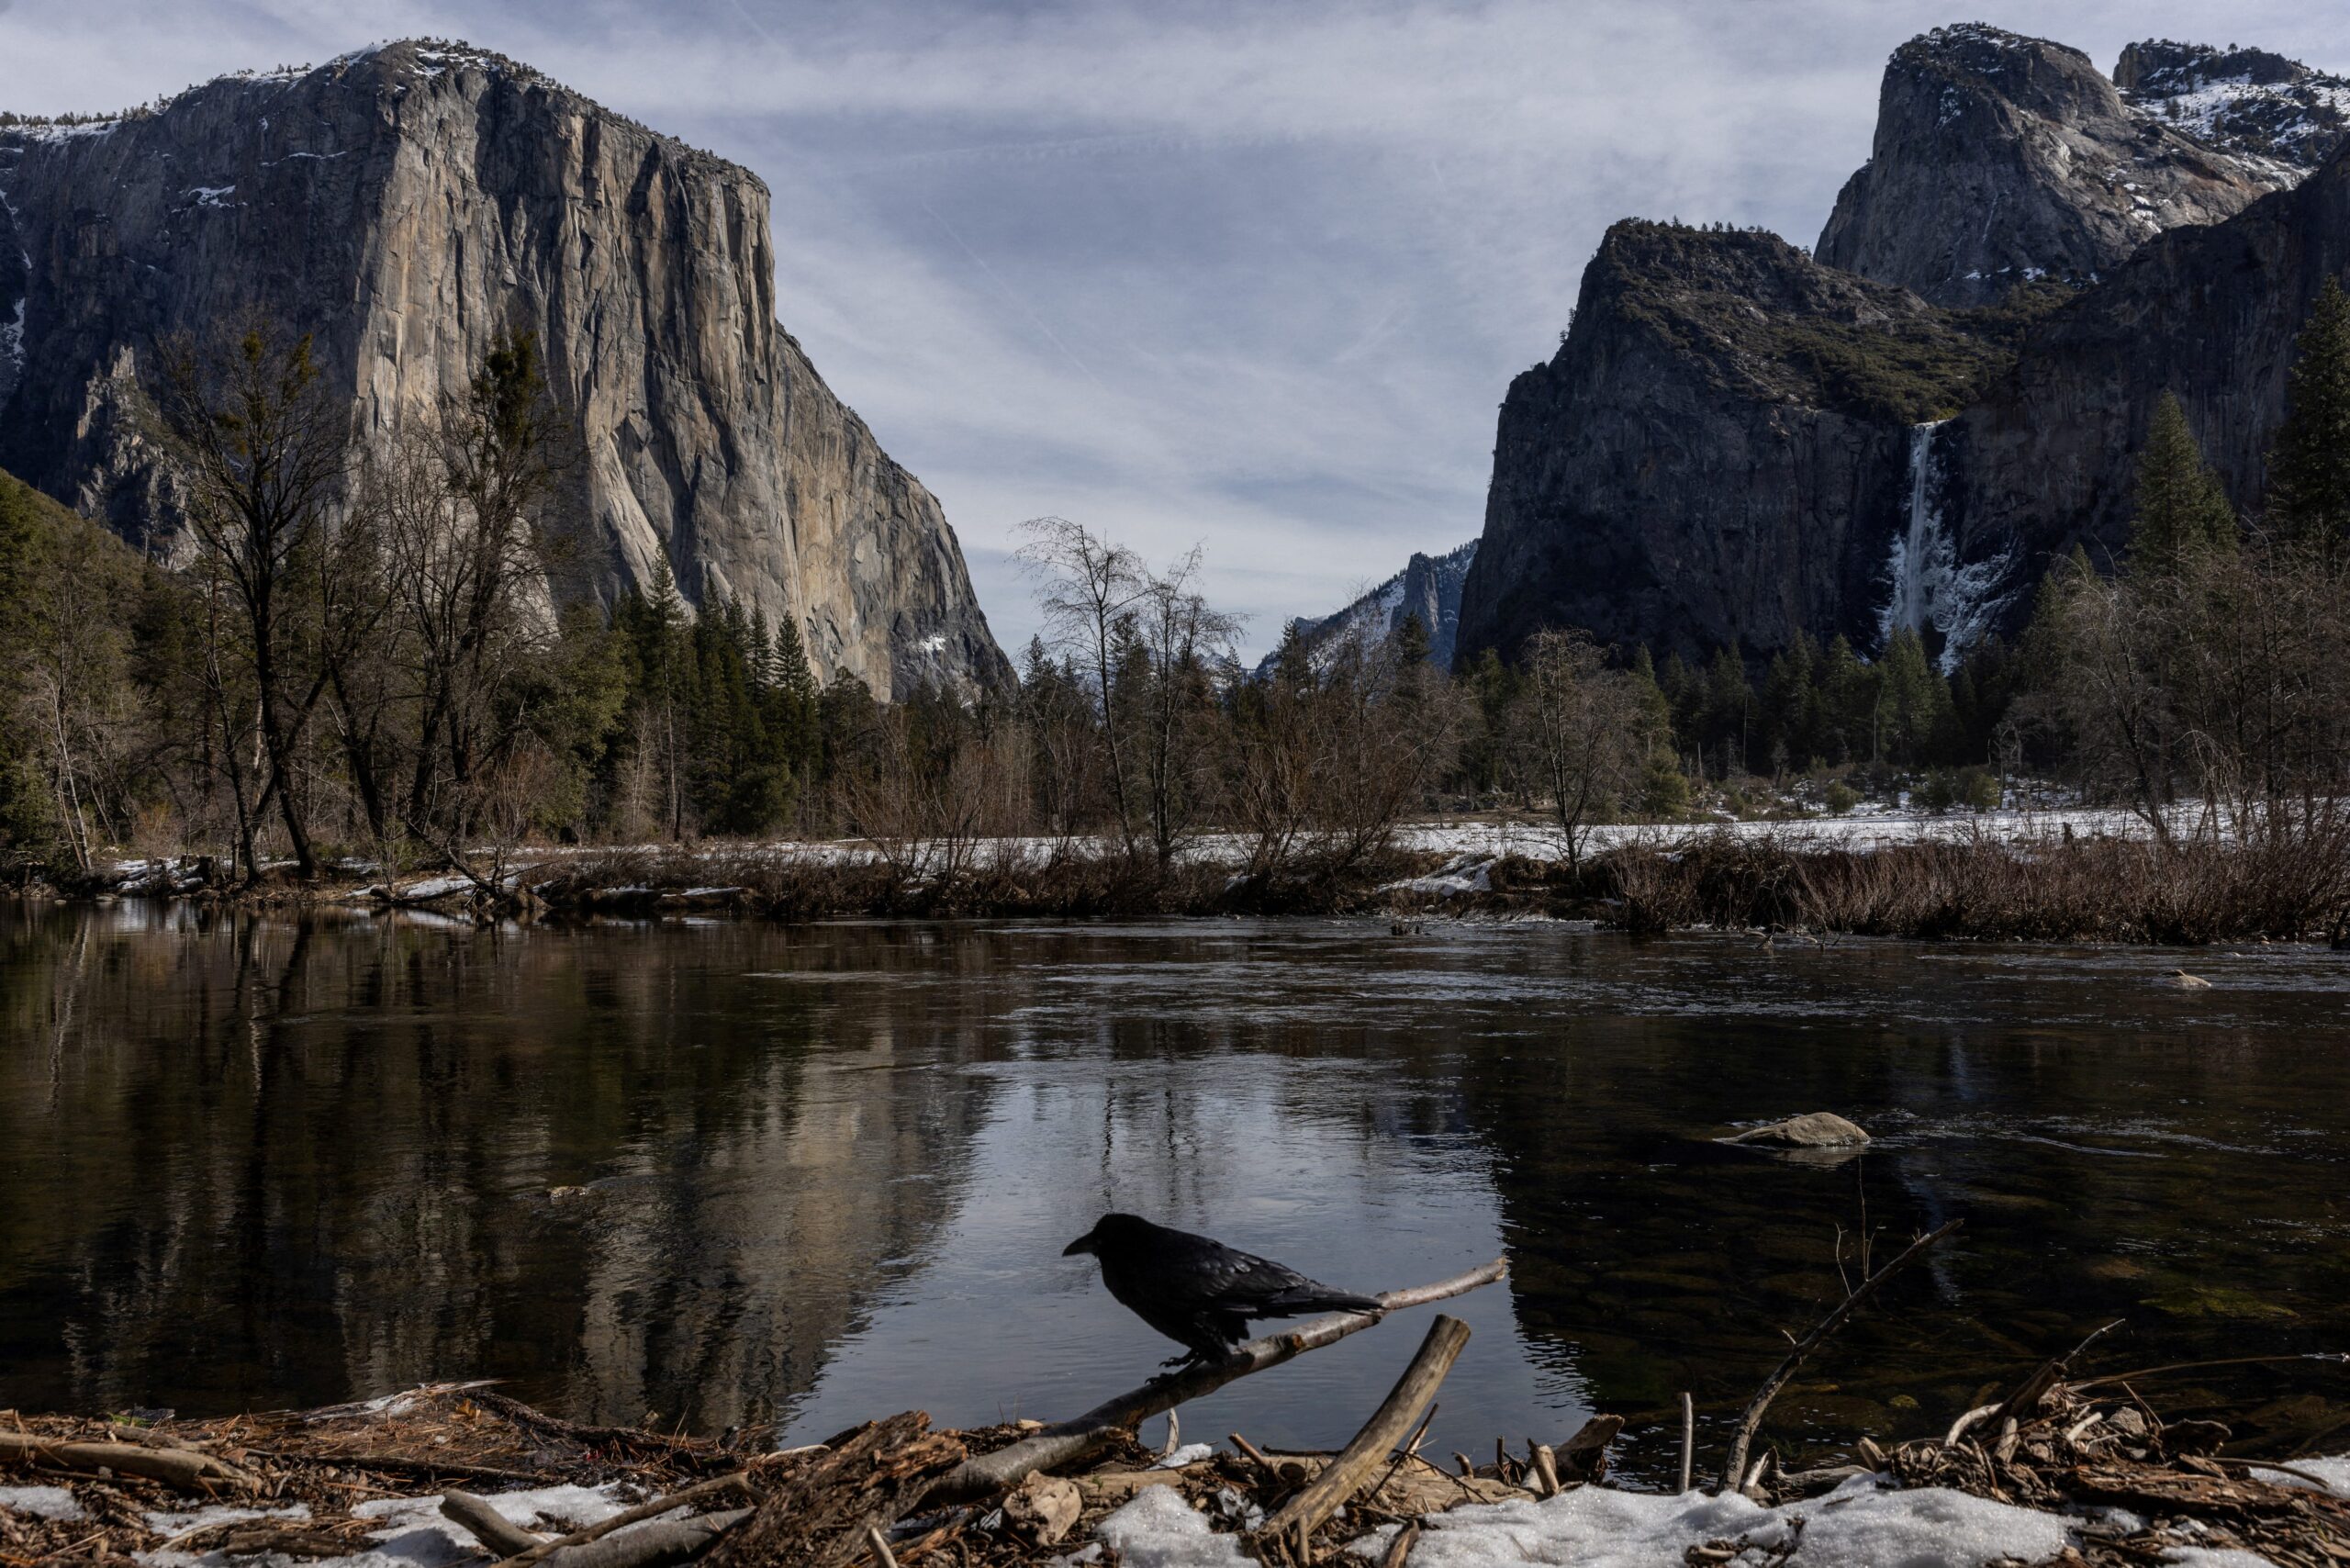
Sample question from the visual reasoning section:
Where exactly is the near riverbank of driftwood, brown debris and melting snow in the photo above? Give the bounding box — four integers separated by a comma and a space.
0, 1361, 2350, 1568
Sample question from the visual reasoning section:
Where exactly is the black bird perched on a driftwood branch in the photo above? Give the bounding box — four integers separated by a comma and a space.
1060, 1213, 1380, 1366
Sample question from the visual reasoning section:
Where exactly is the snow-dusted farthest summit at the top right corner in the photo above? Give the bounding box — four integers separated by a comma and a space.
2112, 38, 2350, 176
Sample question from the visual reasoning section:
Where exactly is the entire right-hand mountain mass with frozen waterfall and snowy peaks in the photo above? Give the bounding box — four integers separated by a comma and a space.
1460, 26, 2350, 667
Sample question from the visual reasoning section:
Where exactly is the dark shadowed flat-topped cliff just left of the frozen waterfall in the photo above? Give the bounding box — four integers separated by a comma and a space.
1460, 223, 2021, 658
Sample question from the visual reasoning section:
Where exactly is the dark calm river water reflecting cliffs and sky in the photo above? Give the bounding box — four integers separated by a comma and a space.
0, 905, 2350, 1474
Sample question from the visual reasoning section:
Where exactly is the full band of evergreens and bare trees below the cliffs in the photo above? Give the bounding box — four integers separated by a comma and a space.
0, 282, 2350, 879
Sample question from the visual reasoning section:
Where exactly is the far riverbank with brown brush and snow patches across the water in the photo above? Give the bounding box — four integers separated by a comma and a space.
30, 811, 2350, 947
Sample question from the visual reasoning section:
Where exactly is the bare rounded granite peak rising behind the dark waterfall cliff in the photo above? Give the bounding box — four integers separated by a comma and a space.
1817, 24, 2308, 306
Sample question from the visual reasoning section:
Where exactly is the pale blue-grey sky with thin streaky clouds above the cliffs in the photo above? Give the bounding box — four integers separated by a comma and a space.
0, 0, 2350, 654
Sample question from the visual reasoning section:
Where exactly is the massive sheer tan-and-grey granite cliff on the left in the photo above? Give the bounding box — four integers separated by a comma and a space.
0, 42, 1011, 693
